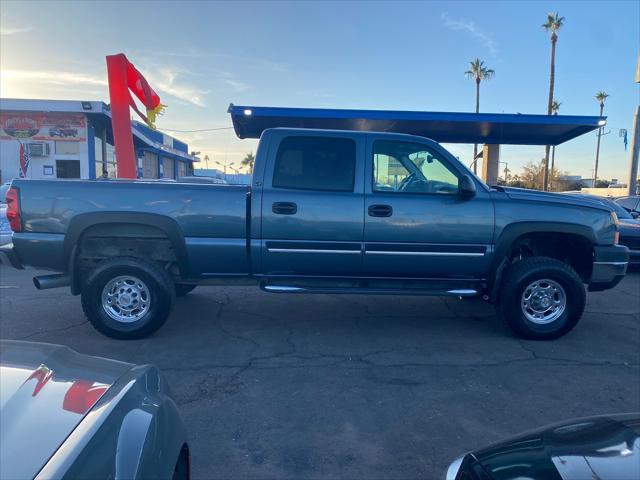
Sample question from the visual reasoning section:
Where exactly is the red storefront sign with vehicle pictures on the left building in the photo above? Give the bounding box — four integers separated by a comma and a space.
0, 112, 87, 142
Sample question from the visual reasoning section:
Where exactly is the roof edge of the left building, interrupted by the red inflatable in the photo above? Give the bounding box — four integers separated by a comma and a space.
0, 98, 199, 162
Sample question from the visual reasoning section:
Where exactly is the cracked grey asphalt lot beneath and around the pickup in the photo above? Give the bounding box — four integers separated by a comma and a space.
0, 266, 640, 479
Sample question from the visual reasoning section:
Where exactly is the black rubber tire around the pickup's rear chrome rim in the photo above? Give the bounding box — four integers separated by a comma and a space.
82, 257, 175, 339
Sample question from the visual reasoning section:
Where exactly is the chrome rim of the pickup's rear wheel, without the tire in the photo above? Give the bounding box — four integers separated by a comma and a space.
102, 275, 151, 323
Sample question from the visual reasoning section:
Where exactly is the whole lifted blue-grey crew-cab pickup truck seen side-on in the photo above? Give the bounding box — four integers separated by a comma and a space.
0, 128, 628, 339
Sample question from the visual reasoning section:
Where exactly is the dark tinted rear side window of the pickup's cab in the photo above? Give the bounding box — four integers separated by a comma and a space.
273, 137, 356, 192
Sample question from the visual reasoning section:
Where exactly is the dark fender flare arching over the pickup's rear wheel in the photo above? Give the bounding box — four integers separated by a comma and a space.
63, 212, 189, 277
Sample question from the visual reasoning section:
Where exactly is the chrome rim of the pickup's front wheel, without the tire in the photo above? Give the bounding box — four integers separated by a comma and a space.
520, 278, 567, 325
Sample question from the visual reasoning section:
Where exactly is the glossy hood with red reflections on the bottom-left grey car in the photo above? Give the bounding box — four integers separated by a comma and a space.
0, 340, 133, 478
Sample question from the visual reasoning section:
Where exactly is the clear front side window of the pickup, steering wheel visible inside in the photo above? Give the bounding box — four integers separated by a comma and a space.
373, 140, 458, 195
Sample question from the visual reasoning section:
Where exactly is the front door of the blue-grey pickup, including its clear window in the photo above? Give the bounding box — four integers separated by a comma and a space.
364, 135, 494, 278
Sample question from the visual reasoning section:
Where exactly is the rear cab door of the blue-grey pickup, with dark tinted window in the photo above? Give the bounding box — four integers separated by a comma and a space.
261, 130, 365, 276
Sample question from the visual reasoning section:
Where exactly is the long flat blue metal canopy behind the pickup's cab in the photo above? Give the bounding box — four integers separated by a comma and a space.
228, 104, 607, 145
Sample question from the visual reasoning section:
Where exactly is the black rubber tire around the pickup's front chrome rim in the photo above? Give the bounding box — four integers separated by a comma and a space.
497, 257, 586, 340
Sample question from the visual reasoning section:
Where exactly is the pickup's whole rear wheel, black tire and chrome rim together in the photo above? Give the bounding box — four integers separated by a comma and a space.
82, 257, 175, 339
